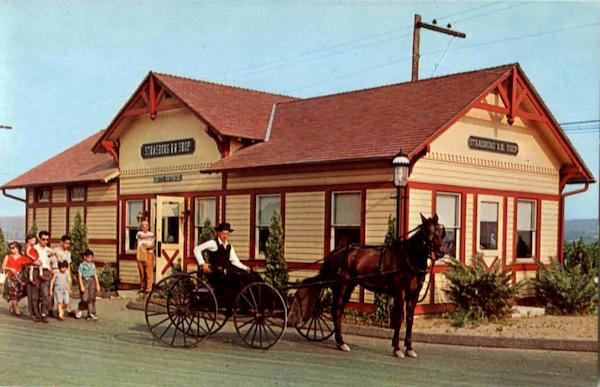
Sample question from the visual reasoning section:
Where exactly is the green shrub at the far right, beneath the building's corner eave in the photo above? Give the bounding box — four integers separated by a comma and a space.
531, 258, 596, 315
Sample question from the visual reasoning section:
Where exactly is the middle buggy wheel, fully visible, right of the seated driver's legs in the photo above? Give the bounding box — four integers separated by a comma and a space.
233, 282, 287, 349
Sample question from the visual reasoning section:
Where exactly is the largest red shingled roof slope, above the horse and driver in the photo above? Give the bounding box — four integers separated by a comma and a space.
204, 64, 515, 172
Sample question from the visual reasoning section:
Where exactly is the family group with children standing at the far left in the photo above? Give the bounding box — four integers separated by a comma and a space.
2, 231, 100, 323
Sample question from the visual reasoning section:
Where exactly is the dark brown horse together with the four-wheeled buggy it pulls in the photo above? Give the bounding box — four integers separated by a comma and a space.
145, 216, 445, 357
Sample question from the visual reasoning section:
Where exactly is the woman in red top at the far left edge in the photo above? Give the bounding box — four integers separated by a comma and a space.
2, 242, 31, 316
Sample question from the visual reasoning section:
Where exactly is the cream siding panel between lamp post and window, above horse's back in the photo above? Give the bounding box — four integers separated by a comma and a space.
365, 188, 396, 245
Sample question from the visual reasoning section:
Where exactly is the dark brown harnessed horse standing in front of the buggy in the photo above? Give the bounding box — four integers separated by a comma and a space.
302, 214, 446, 357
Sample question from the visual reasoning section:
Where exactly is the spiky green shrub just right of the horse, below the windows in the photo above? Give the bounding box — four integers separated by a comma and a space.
444, 254, 523, 326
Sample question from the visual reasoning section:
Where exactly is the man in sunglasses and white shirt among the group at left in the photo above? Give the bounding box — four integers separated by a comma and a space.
27, 231, 54, 323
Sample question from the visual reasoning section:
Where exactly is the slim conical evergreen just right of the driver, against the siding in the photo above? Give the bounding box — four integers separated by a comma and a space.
265, 211, 289, 298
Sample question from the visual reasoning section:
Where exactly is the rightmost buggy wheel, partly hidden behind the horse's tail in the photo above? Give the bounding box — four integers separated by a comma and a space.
295, 288, 335, 341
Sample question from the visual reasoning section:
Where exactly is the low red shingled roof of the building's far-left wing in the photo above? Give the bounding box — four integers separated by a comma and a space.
0, 130, 119, 188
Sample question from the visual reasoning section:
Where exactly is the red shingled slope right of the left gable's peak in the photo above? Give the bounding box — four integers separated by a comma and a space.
152, 72, 295, 140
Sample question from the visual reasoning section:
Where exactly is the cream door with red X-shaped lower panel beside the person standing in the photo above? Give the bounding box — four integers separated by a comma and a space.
155, 196, 185, 282
